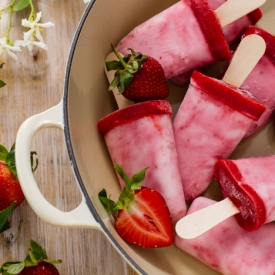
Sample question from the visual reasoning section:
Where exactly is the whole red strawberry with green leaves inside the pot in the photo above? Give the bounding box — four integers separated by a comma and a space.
106, 45, 169, 102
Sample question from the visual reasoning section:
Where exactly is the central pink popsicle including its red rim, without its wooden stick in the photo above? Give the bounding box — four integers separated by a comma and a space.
173, 71, 265, 200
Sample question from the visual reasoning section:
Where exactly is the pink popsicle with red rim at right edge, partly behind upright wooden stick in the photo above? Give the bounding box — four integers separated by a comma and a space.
237, 26, 275, 138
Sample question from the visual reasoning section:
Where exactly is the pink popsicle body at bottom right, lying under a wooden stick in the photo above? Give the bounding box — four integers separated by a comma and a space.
175, 197, 275, 275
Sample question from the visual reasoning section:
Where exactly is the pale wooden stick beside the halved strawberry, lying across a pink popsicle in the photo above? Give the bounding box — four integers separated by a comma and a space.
176, 198, 240, 239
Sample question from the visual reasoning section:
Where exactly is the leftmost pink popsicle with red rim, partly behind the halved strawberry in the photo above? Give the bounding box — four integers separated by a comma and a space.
98, 100, 186, 220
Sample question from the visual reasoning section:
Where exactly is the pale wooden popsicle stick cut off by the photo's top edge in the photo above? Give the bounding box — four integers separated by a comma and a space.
215, 0, 266, 28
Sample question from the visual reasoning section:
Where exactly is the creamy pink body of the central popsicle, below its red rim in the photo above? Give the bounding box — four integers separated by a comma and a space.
173, 81, 252, 200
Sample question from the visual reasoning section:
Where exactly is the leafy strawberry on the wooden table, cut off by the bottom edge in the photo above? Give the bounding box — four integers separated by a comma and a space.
0, 240, 61, 275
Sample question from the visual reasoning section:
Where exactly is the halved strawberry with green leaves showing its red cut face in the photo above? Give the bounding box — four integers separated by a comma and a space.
98, 164, 174, 248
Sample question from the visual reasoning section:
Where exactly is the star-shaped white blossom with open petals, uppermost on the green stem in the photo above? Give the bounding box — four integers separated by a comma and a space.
22, 12, 54, 44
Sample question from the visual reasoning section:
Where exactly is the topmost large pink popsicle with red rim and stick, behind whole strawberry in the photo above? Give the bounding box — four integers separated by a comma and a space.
117, 0, 265, 84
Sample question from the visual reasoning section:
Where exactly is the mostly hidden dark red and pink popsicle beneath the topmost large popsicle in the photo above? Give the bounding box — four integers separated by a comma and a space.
171, 0, 262, 86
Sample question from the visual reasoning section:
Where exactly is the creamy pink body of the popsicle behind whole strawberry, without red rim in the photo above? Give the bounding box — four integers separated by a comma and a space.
117, 0, 215, 79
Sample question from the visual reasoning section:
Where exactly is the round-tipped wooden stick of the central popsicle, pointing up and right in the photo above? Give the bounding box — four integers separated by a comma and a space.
222, 34, 266, 87
